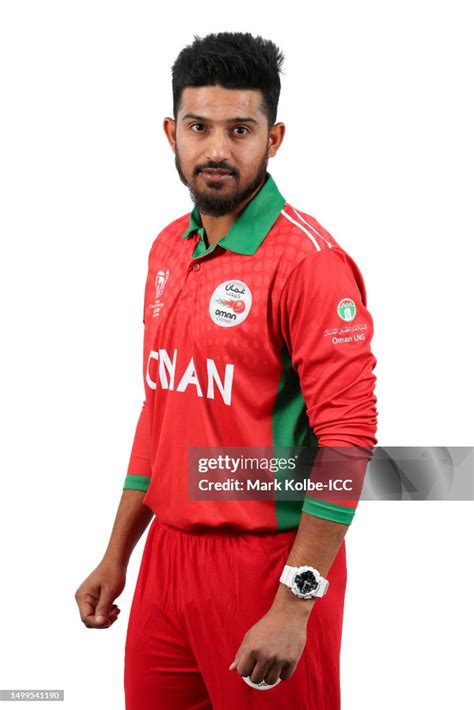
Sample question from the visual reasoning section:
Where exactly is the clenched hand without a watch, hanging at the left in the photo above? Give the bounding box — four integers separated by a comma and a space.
75, 560, 126, 629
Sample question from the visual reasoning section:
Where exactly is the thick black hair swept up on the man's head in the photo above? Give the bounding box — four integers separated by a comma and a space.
171, 32, 284, 126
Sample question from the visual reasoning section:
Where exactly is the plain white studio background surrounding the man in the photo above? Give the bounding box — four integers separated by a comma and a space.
0, 0, 474, 710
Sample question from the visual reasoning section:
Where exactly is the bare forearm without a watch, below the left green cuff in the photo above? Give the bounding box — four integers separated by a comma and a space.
103, 489, 153, 567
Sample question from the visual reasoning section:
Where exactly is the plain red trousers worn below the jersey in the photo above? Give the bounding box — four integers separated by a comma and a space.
124, 517, 346, 710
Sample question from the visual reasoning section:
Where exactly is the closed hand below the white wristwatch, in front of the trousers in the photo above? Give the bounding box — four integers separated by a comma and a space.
229, 601, 308, 685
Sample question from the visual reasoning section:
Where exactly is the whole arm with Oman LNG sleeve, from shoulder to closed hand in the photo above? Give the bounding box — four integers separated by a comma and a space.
229, 249, 377, 684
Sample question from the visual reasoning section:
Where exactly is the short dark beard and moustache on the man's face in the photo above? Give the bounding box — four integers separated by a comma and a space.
174, 146, 268, 217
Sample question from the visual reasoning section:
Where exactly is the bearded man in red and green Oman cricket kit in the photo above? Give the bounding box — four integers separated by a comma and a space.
76, 32, 377, 710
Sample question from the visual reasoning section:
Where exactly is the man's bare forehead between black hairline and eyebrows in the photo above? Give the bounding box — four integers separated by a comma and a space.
179, 86, 263, 121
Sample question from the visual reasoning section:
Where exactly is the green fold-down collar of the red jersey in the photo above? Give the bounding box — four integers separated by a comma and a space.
182, 173, 286, 255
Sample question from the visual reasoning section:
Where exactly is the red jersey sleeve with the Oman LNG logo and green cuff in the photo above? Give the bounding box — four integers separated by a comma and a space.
280, 247, 377, 525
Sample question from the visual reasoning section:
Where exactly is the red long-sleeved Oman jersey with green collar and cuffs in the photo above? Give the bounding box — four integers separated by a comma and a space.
124, 174, 377, 531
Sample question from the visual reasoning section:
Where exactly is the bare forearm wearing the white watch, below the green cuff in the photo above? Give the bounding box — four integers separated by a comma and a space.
273, 513, 349, 616
